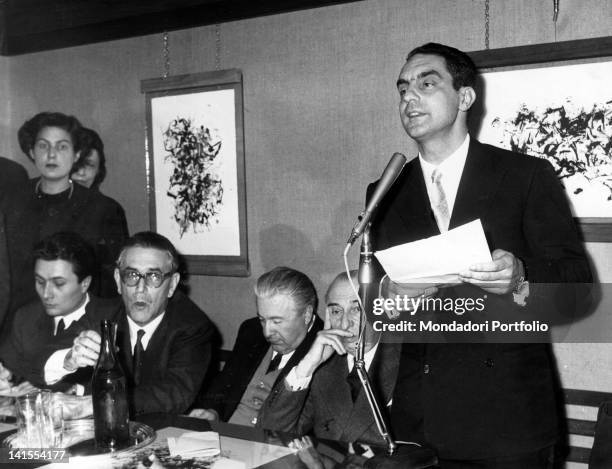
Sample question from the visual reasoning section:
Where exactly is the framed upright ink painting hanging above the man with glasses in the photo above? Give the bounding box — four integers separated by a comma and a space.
141, 69, 250, 277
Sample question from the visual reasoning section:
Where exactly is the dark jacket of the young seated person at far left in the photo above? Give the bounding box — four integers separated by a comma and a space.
0, 296, 117, 391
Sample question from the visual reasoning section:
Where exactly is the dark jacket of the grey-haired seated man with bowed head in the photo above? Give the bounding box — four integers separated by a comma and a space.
196, 314, 323, 421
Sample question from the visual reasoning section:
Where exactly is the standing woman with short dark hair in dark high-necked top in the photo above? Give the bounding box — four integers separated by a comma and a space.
4, 112, 128, 318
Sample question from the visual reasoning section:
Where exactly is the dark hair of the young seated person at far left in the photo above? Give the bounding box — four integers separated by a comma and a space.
33, 231, 96, 282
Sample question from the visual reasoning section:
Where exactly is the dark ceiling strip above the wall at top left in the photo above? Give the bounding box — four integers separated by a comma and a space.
0, 0, 359, 55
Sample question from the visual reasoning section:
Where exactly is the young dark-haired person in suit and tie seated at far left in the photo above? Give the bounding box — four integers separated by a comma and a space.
0, 232, 112, 390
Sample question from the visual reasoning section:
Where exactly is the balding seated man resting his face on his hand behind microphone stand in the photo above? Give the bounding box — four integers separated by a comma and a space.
259, 271, 400, 445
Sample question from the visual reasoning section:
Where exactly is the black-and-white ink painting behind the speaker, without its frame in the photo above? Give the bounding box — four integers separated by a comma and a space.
478, 62, 612, 218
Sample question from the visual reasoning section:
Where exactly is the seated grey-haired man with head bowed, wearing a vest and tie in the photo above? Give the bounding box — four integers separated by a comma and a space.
190, 267, 322, 426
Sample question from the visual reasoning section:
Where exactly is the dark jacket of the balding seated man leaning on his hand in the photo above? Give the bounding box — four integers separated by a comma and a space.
257, 343, 401, 445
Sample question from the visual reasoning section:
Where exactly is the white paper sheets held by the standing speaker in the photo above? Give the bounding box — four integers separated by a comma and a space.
375, 219, 491, 284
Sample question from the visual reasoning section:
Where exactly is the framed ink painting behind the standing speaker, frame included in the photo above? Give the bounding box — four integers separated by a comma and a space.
468, 36, 612, 242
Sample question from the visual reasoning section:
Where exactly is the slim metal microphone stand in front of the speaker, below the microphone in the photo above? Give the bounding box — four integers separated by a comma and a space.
355, 223, 397, 456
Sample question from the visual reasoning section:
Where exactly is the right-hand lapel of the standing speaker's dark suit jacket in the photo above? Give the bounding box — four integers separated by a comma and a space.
449, 139, 505, 229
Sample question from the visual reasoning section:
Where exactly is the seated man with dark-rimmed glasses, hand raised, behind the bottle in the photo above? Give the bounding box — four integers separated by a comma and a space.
40, 232, 214, 417
